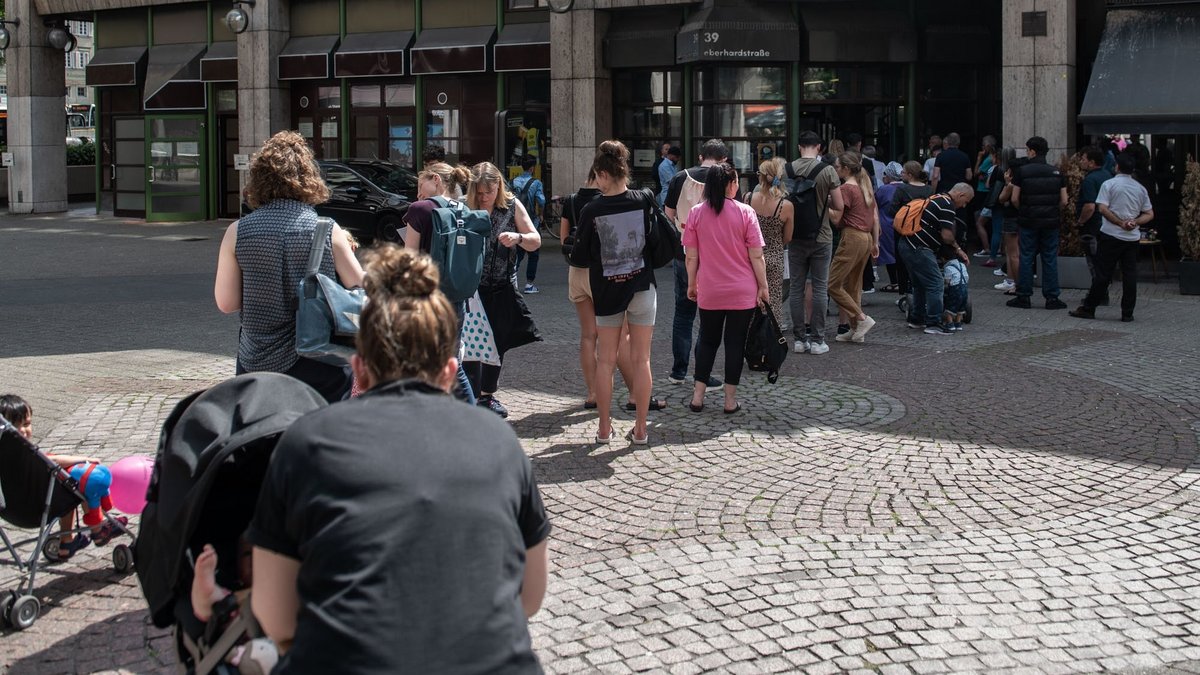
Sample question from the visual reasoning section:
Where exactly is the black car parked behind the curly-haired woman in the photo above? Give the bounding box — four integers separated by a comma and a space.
317, 160, 416, 244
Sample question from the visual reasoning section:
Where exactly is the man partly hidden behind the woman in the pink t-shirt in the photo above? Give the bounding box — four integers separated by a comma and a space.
662, 138, 740, 387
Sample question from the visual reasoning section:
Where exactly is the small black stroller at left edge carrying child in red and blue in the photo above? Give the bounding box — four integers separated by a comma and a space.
0, 418, 133, 631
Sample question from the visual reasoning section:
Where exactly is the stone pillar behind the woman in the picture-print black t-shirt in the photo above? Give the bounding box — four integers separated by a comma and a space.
550, 5, 612, 195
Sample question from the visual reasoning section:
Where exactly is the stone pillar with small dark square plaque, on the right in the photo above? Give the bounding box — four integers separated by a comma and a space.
1001, 0, 1078, 163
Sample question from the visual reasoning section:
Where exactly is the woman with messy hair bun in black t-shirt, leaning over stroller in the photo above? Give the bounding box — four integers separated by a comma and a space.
255, 244, 550, 675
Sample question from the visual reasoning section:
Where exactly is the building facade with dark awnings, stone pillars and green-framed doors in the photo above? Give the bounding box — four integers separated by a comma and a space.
7, 0, 1178, 220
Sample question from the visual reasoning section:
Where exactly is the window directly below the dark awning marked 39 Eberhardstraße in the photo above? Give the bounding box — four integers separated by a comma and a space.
694, 66, 788, 174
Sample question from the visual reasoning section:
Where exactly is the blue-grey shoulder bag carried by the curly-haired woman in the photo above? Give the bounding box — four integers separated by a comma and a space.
296, 217, 367, 365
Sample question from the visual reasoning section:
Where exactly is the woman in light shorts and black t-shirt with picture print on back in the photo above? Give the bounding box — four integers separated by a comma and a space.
571, 141, 658, 446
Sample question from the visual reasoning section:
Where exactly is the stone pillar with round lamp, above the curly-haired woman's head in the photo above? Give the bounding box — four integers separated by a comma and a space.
238, 0, 292, 159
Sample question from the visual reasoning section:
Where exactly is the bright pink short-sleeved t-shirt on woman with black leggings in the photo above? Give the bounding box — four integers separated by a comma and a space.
683, 199, 763, 310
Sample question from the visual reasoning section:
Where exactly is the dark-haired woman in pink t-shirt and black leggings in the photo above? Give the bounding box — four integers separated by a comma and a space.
683, 162, 769, 414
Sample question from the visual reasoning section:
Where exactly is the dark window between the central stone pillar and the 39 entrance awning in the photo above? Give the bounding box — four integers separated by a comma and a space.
612, 71, 683, 186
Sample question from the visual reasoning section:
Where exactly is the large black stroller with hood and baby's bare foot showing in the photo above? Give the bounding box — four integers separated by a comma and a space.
134, 372, 326, 675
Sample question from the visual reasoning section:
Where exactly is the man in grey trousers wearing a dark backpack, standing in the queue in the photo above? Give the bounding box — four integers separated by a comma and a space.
787, 131, 842, 354
